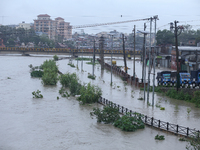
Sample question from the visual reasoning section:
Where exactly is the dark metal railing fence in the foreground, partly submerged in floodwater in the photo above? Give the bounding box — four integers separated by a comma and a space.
98, 97, 200, 138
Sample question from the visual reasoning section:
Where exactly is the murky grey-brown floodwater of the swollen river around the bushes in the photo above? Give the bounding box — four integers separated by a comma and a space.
0, 56, 200, 150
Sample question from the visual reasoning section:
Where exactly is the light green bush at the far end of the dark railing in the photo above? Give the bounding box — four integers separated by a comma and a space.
78, 83, 102, 104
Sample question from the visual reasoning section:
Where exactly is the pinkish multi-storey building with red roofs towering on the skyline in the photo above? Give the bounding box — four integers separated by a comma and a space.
34, 14, 72, 40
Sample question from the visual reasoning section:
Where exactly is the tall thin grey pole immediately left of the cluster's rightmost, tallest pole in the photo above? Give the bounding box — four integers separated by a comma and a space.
147, 17, 153, 104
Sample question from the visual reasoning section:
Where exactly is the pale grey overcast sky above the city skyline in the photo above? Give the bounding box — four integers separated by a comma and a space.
0, 0, 200, 33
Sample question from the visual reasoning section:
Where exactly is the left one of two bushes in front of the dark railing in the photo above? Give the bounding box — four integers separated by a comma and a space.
90, 106, 120, 124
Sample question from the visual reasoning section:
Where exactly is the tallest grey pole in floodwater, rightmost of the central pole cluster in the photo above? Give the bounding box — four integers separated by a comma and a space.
152, 16, 158, 106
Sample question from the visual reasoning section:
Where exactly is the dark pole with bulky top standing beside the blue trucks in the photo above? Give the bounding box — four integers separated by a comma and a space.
170, 20, 183, 92
